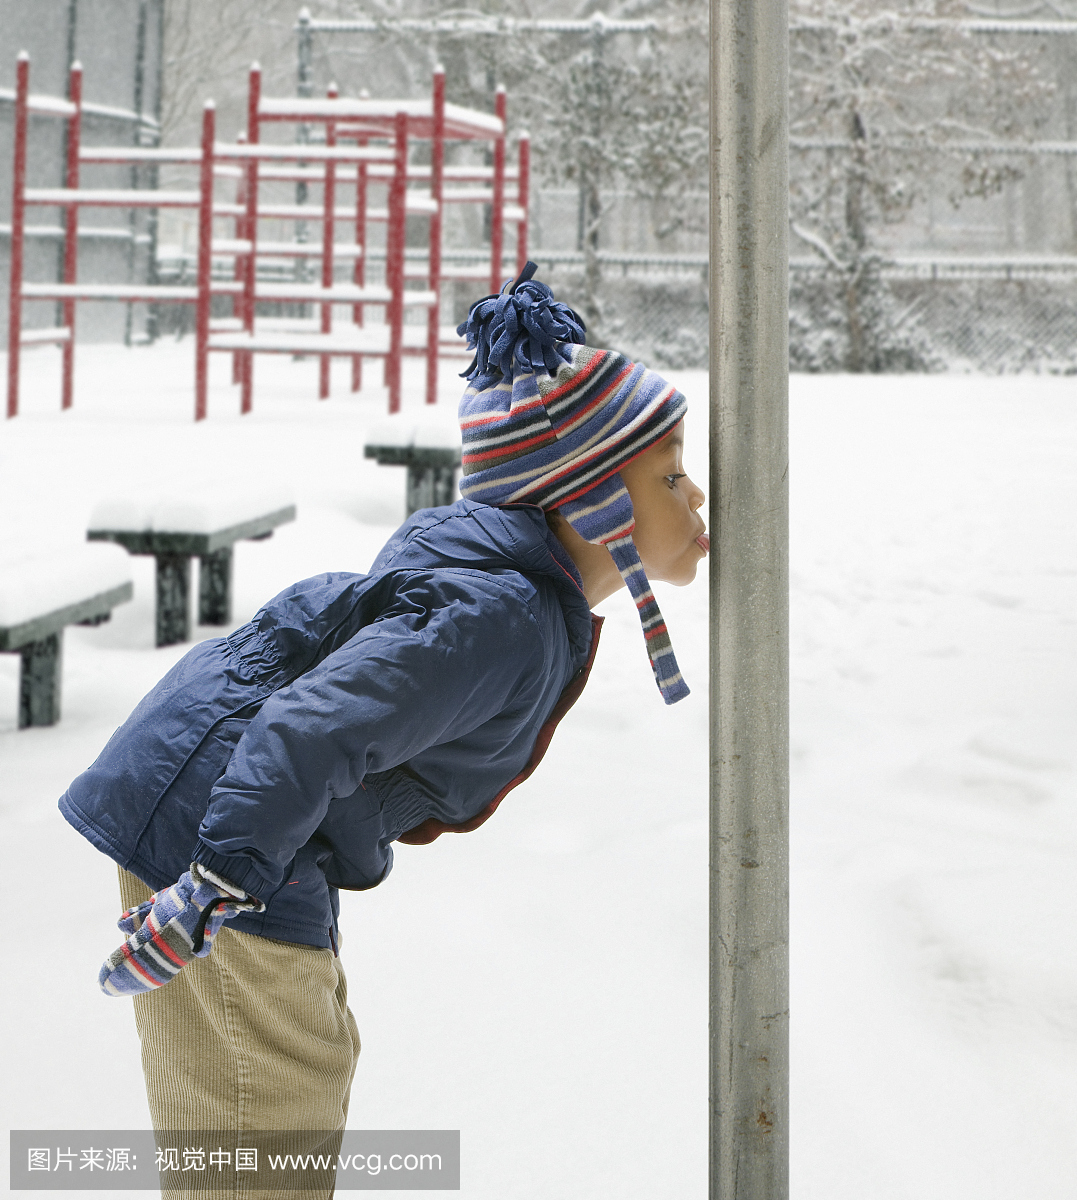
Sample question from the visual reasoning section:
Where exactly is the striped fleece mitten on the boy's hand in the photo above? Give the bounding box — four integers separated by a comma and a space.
97, 863, 265, 996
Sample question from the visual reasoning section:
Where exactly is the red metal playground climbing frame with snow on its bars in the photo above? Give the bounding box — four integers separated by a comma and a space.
7, 54, 530, 420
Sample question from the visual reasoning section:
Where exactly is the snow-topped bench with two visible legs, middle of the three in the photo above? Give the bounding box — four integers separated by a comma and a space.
86, 493, 295, 646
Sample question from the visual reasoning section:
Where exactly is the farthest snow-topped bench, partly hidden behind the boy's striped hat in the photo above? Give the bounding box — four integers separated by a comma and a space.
363, 407, 461, 516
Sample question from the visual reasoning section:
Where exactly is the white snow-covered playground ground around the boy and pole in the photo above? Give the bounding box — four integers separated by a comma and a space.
0, 342, 1077, 1200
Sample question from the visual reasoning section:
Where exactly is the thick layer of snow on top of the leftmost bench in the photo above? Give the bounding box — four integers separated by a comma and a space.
0, 545, 131, 628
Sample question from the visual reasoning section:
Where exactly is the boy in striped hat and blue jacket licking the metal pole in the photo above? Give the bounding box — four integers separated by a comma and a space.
60, 263, 708, 1176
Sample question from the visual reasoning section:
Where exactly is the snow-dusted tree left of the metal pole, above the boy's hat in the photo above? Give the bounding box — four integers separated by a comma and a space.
261, 0, 708, 340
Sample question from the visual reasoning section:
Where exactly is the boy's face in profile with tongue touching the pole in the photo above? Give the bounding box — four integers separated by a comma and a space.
619, 421, 709, 587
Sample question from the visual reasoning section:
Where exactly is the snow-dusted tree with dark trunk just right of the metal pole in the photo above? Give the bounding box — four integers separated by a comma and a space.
789, 0, 1053, 371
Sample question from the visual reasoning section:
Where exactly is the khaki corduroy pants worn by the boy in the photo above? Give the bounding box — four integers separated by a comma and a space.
120, 868, 360, 1200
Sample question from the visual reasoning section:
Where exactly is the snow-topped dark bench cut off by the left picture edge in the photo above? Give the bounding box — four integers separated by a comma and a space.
0, 546, 133, 730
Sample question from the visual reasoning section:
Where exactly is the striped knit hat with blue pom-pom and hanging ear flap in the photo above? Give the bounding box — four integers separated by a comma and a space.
457, 263, 688, 704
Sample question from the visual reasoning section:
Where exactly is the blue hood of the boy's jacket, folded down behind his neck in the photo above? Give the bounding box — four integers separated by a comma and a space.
371, 500, 591, 656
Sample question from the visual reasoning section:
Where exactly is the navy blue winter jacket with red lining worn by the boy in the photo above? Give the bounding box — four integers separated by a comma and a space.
60, 500, 597, 949
